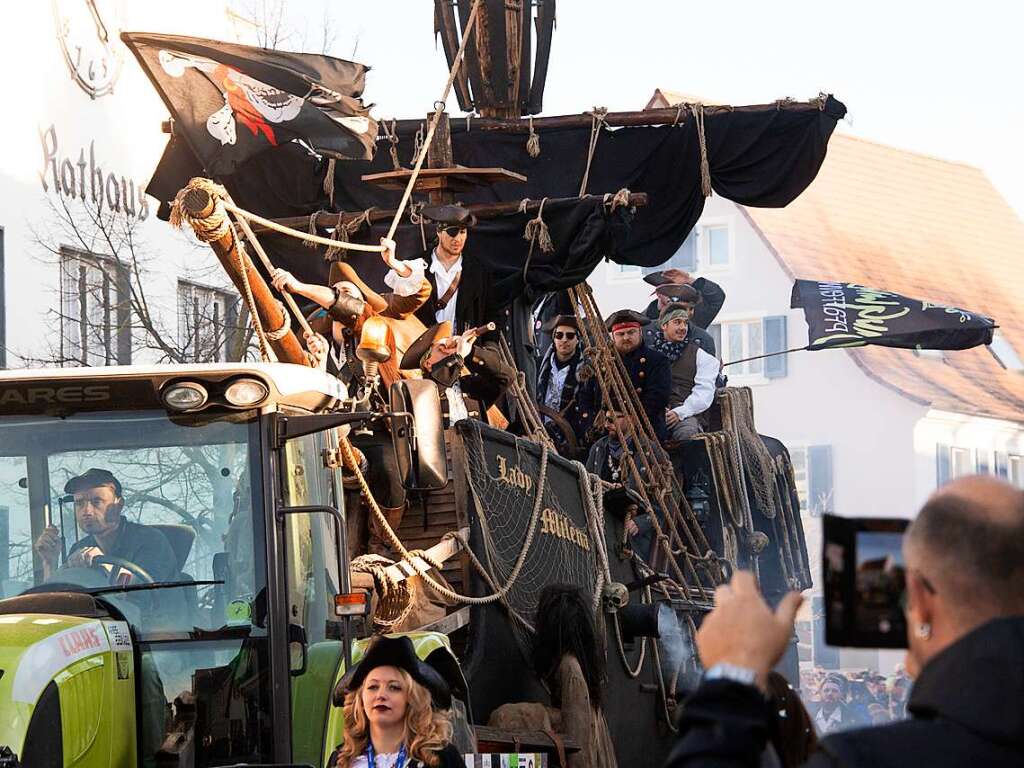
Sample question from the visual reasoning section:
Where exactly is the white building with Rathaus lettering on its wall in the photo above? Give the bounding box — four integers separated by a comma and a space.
0, 0, 247, 367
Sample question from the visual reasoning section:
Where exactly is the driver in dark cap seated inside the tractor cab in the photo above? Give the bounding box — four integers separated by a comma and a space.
34, 467, 176, 582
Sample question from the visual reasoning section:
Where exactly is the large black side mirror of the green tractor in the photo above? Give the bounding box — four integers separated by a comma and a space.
391, 379, 447, 490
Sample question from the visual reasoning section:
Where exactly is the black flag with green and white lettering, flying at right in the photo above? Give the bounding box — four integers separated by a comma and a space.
790, 280, 995, 349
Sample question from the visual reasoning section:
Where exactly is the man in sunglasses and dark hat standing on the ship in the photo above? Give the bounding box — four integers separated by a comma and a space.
537, 314, 597, 458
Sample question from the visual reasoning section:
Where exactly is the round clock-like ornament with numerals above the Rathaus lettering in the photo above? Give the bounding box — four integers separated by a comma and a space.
53, 0, 122, 98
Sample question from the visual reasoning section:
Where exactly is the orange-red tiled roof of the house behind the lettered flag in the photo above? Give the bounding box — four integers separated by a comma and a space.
741, 134, 1024, 422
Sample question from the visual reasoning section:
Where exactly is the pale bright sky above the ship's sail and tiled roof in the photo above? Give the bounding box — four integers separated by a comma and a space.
249, 0, 1024, 218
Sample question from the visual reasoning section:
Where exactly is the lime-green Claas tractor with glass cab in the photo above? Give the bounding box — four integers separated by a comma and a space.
0, 364, 464, 768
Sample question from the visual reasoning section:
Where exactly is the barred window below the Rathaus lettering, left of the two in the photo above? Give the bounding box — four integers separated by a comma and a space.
60, 249, 131, 366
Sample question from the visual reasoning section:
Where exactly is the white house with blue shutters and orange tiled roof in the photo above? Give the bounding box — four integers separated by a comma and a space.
590, 105, 1024, 668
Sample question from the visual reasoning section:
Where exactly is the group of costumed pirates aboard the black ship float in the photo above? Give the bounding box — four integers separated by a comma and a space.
271, 205, 725, 555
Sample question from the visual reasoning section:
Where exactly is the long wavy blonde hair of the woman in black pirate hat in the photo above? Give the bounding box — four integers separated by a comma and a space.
337, 669, 452, 768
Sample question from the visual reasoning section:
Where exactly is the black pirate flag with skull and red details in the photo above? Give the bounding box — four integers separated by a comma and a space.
121, 33, 377, 176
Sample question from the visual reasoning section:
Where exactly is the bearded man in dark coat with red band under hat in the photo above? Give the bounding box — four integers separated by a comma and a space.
604, 309, 672, 440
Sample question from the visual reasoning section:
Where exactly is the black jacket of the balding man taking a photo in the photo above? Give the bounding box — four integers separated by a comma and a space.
666, 616, 1024, 768
